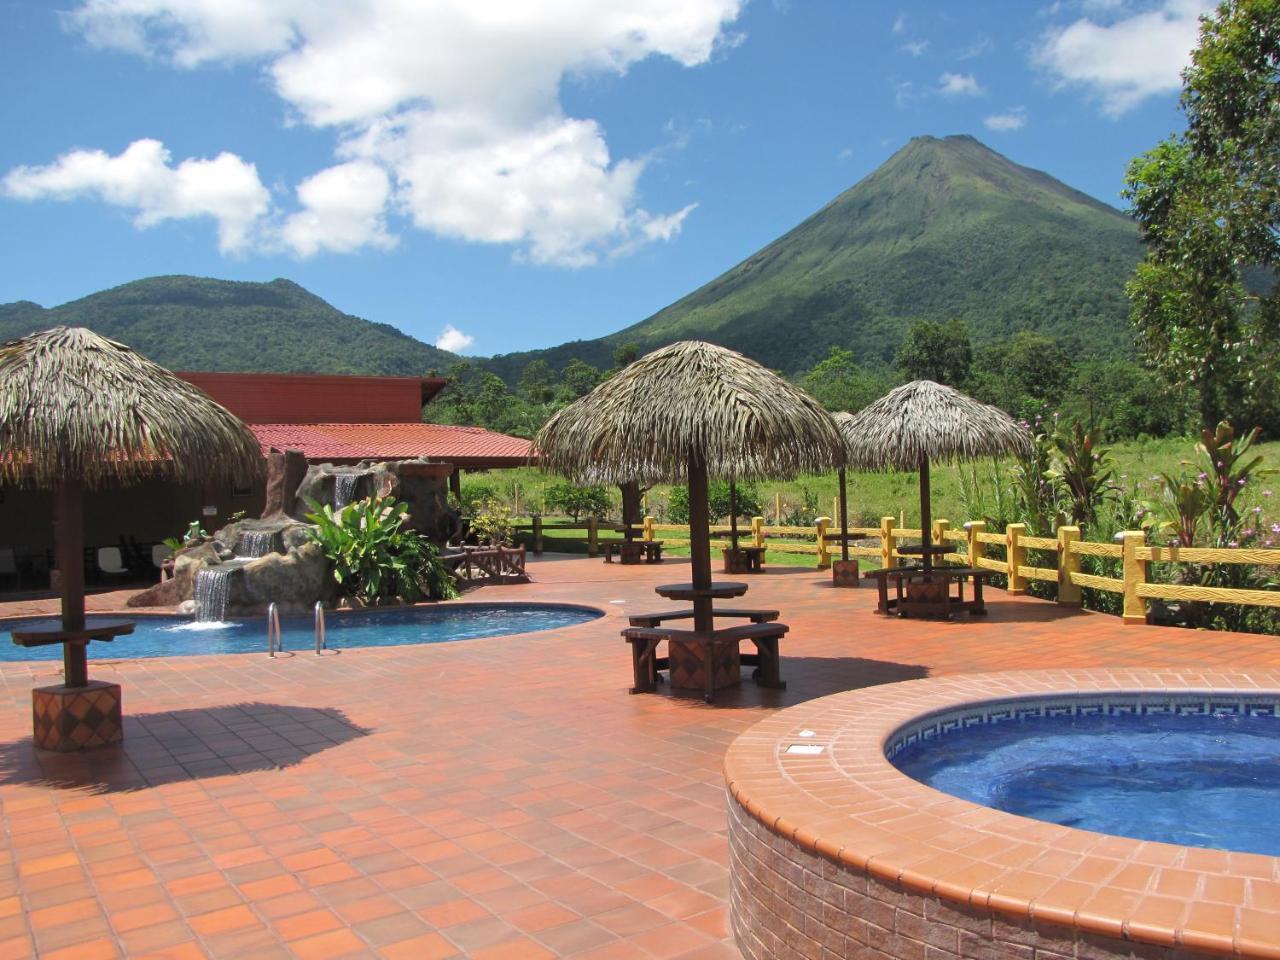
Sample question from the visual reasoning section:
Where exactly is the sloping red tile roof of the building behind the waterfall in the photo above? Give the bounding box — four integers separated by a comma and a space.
250, 424, 532, 467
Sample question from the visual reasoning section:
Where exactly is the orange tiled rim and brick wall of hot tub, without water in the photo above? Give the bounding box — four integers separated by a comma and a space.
724, 669, 1280, 960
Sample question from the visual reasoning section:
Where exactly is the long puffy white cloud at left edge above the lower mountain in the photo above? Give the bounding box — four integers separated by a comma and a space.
3, 140, 270, 253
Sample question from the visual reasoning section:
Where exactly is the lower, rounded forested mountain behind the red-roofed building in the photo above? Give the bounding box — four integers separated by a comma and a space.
0, 276, 457, 376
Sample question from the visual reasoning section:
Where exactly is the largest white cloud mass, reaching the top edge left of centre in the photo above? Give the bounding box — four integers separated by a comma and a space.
37, 0, 745, 265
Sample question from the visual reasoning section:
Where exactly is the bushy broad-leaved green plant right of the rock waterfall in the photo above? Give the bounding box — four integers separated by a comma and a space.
306, 497, 457, 603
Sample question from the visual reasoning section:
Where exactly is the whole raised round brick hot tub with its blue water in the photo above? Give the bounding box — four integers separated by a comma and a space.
724, 669, 1280, 960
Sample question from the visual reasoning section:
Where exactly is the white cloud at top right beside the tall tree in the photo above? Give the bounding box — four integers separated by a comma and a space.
1033, 0, 1213, 116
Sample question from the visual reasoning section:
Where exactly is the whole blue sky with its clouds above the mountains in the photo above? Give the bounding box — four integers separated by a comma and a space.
0, 0, 1210, 355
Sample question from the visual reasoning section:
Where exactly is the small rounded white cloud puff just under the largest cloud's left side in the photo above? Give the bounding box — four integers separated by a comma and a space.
280, 161, 396, 257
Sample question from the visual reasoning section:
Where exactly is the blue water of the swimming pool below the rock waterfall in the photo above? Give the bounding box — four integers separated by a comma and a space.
0, 603, 600, 660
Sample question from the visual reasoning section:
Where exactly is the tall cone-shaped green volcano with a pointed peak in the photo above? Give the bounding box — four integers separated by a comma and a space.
489, 137, 1140, 380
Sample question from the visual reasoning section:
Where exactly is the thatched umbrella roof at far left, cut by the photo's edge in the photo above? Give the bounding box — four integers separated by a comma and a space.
0, 326, 262, 489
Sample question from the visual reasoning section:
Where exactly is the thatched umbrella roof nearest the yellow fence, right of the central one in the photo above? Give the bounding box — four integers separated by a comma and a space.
838, 380, 1032, 470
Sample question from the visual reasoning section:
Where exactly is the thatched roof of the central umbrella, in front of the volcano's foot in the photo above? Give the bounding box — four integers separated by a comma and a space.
534, 340, 845, 483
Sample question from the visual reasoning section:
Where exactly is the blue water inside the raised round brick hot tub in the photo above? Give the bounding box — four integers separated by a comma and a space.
892, 714, 1280, 855
